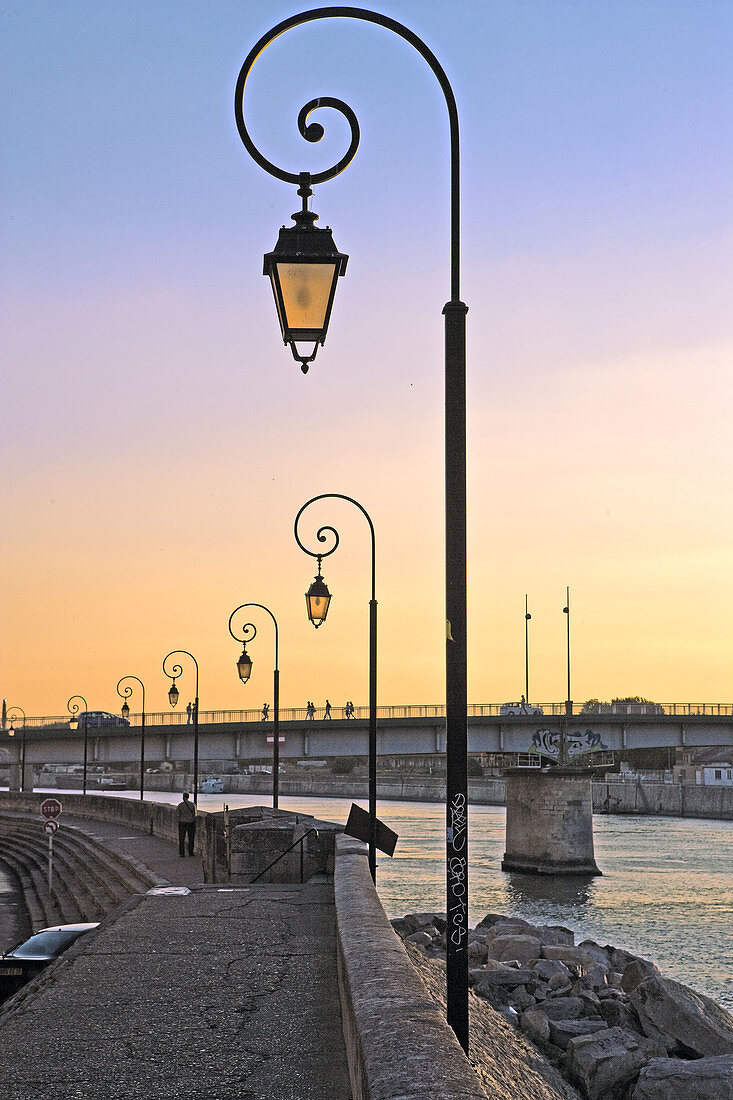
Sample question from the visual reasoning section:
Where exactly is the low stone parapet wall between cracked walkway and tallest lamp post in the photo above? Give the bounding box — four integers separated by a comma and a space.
333, 836, 486, 1100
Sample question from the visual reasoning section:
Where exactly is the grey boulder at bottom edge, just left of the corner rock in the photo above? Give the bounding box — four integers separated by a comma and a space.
563, 1025, 664, 1100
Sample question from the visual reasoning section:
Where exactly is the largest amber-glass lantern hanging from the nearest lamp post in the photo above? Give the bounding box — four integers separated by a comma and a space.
263, 175, 349, 374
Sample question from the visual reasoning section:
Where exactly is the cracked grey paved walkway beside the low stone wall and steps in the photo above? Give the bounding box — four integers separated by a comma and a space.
0, 817, 351, 1100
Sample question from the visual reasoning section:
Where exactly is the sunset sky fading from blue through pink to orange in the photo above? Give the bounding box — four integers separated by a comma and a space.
0, 0, 733, 715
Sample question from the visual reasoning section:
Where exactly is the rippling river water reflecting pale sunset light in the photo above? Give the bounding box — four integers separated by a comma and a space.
7, 791, 733, 1009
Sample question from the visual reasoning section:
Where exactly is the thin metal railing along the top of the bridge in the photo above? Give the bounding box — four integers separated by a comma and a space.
6, 703, 733, 733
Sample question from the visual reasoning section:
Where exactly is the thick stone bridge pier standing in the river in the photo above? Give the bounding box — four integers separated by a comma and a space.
502, 767, 602, 875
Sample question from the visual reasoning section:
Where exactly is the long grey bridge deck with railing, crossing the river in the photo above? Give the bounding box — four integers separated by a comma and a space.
5, 703, 733, 768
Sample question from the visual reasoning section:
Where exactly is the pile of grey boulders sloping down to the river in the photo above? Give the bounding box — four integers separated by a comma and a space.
392, 913, 733, 1100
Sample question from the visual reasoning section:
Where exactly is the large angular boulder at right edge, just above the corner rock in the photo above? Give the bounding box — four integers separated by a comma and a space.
630, 975, 733, 1058
